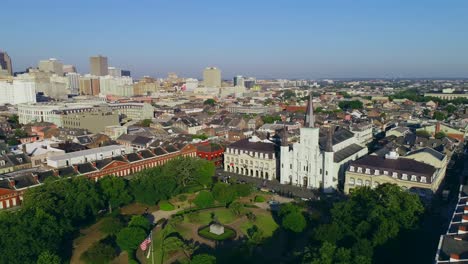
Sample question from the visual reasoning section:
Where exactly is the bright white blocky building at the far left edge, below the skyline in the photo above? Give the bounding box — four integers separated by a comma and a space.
0, 79, 36, 105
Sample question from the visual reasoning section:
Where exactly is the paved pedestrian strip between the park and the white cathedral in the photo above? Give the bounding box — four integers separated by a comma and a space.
216, 170, 316, 199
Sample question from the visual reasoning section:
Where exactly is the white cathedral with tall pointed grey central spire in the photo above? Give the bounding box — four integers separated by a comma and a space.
280, 93, 368, 192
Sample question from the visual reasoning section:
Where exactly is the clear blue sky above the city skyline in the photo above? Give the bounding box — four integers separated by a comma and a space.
0, 0, 468, 79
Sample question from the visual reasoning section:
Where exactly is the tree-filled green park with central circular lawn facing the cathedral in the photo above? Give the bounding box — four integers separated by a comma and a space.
0, 157, 428, 264
